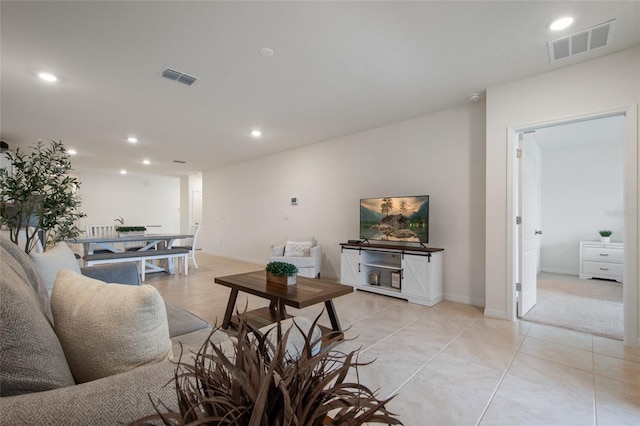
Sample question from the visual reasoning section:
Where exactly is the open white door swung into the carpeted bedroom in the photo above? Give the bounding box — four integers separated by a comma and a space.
517, 133, 540, 317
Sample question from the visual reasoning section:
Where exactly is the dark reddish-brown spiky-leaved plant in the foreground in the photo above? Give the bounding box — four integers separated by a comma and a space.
133, 314, 402, 426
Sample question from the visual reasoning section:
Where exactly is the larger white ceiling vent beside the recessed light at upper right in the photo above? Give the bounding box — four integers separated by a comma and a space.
547, 19, 615, 62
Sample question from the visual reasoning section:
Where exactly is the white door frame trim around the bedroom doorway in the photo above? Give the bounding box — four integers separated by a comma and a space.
505, 104, 640, 346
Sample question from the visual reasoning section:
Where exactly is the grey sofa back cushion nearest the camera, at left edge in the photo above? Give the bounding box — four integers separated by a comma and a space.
0, 240, 75, 397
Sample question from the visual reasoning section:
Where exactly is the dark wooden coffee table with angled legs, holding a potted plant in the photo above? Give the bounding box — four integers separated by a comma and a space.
215, 271, 353, 338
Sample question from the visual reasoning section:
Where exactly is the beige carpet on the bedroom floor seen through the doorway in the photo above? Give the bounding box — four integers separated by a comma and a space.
522, 272, 624, 340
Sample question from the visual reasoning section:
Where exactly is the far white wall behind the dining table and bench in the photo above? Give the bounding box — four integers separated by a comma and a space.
79, 173, 180, 233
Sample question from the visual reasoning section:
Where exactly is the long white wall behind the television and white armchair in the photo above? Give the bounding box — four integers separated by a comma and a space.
202, 102, 485, 306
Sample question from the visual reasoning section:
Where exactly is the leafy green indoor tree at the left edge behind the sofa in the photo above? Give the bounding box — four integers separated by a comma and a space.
0, 140, 86, 253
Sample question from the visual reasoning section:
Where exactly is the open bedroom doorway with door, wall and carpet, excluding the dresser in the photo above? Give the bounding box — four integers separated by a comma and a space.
518, 115, 624, 340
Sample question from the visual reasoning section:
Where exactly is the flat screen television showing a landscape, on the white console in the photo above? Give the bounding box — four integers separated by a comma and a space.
360, 195, 429, 243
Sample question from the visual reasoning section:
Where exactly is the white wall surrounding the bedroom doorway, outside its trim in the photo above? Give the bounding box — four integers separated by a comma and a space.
485, 48, 640, 341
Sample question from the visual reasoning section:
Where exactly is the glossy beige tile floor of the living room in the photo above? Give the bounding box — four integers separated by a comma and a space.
146, 254, 640, 426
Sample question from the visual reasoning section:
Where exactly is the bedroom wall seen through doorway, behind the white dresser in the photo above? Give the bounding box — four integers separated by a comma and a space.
540, 141, 624, 275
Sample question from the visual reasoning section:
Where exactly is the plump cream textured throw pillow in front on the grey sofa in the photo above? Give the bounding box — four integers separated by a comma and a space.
51, 270, 172, 383
